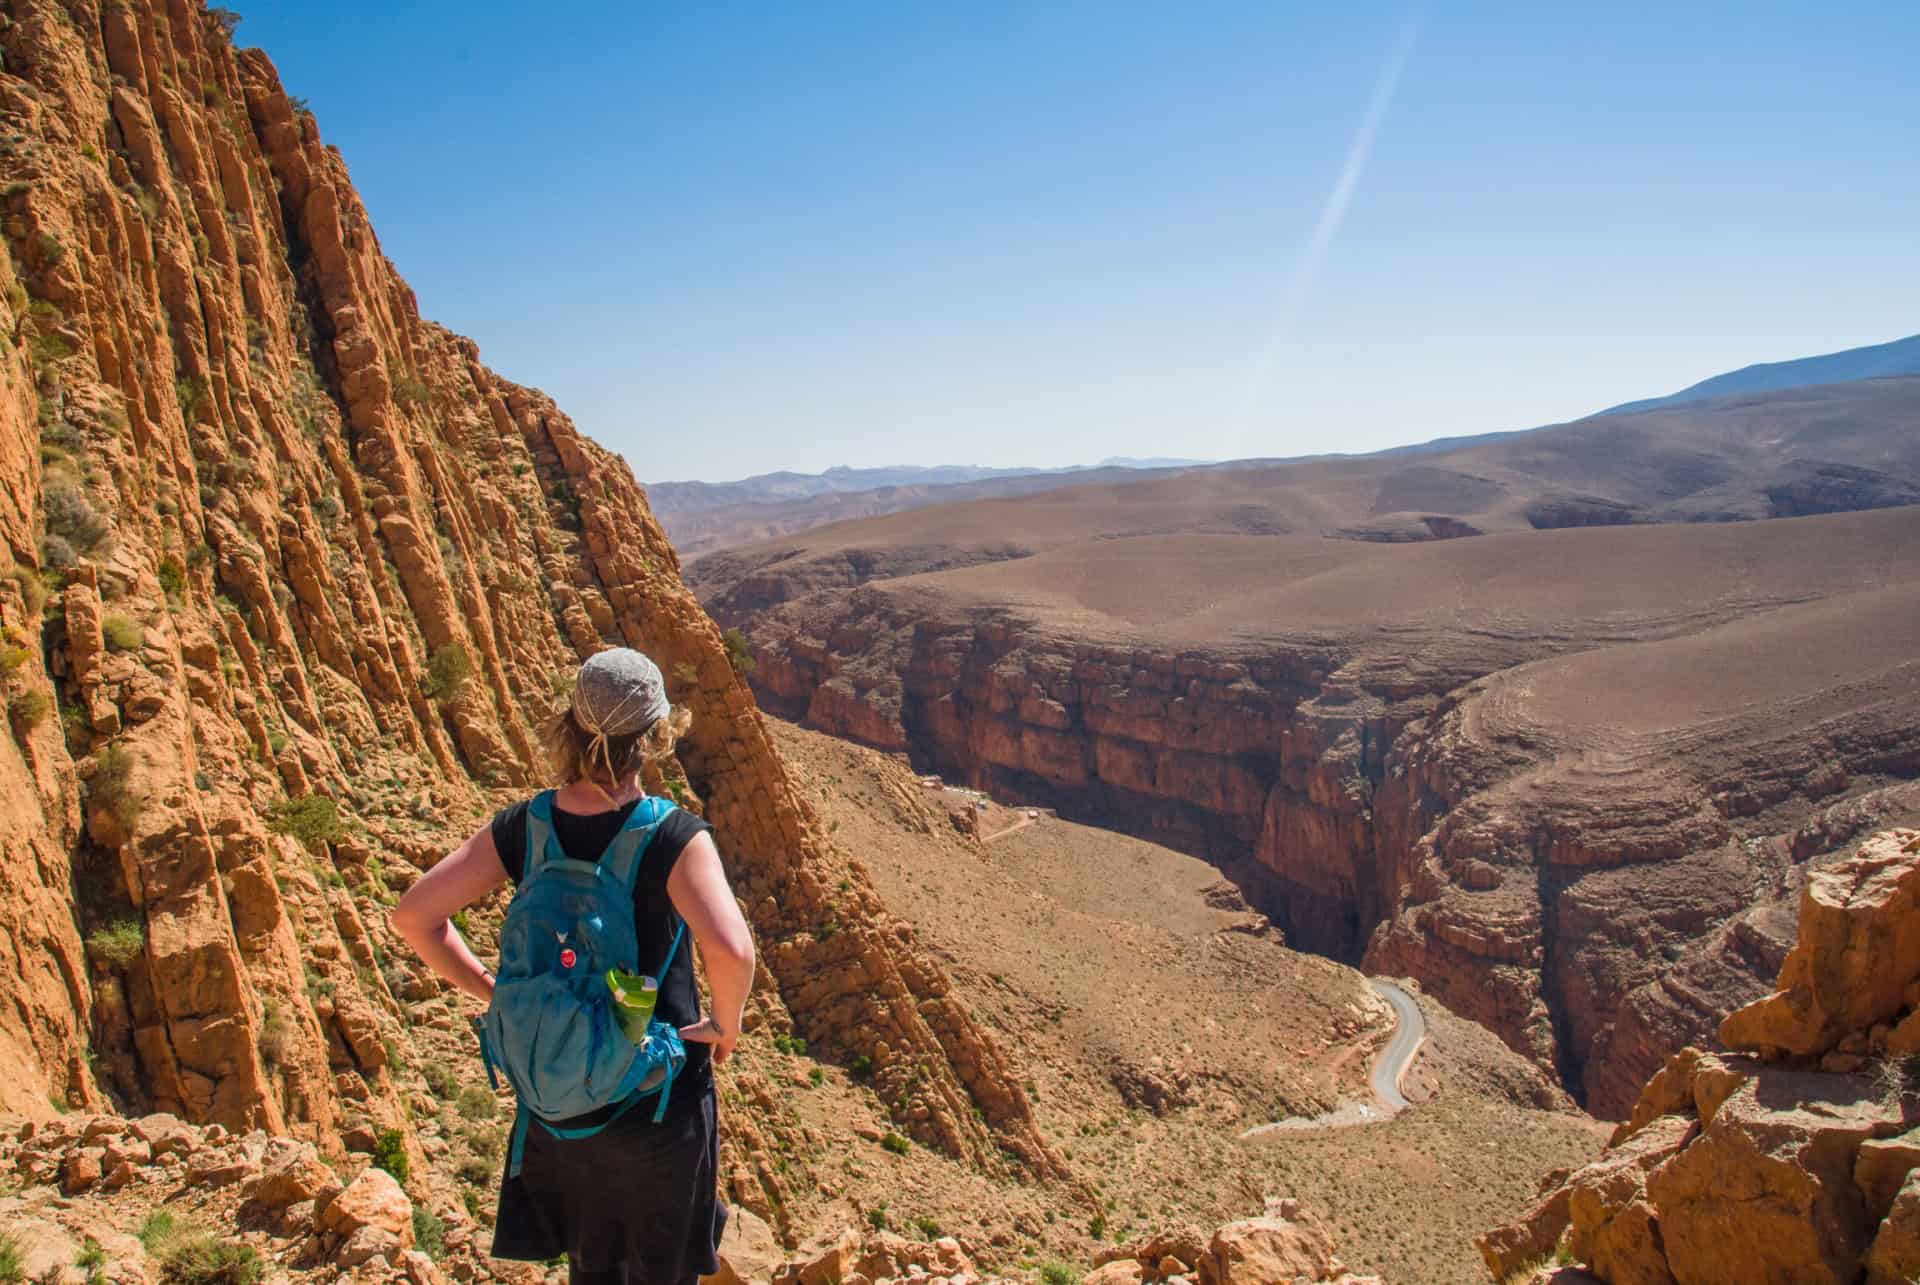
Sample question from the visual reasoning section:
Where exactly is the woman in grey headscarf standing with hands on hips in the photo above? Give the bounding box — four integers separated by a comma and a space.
394, 647, 753, 1285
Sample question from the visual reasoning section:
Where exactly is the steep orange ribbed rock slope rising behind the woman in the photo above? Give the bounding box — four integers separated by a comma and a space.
0, 0, 1056, 1208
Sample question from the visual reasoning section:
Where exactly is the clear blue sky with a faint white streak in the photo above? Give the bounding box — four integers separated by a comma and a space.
234, 0, 1920, 480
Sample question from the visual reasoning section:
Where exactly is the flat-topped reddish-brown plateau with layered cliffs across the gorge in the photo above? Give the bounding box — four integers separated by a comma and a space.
714, 507, 1920, 1114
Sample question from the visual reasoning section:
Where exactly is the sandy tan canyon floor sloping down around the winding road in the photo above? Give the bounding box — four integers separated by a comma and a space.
770, 720, 1605, 1283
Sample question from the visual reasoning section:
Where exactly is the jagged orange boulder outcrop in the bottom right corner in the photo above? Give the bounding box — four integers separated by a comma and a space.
1480, 830, 1920, 1285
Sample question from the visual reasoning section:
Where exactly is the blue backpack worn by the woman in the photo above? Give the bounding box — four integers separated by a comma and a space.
474, 789, 687, 1177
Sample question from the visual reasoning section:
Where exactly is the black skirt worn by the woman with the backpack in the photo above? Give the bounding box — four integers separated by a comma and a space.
493, 1078, 726, 1285
